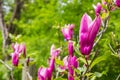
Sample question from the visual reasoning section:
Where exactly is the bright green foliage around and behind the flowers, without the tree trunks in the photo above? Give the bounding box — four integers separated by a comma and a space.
0, 0, 120, 80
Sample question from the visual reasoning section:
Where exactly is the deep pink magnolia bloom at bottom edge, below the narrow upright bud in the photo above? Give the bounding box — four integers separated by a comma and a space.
68, 56, 78, 80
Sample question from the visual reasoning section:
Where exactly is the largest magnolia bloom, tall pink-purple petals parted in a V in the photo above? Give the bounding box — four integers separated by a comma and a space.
79, 13, 101, 55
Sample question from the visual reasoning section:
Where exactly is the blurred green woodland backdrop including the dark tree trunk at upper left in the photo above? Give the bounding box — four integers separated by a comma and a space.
0, 0, 120, 80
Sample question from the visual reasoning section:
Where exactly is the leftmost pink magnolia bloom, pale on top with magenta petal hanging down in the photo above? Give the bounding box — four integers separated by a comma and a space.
11, 43, 26, 66
